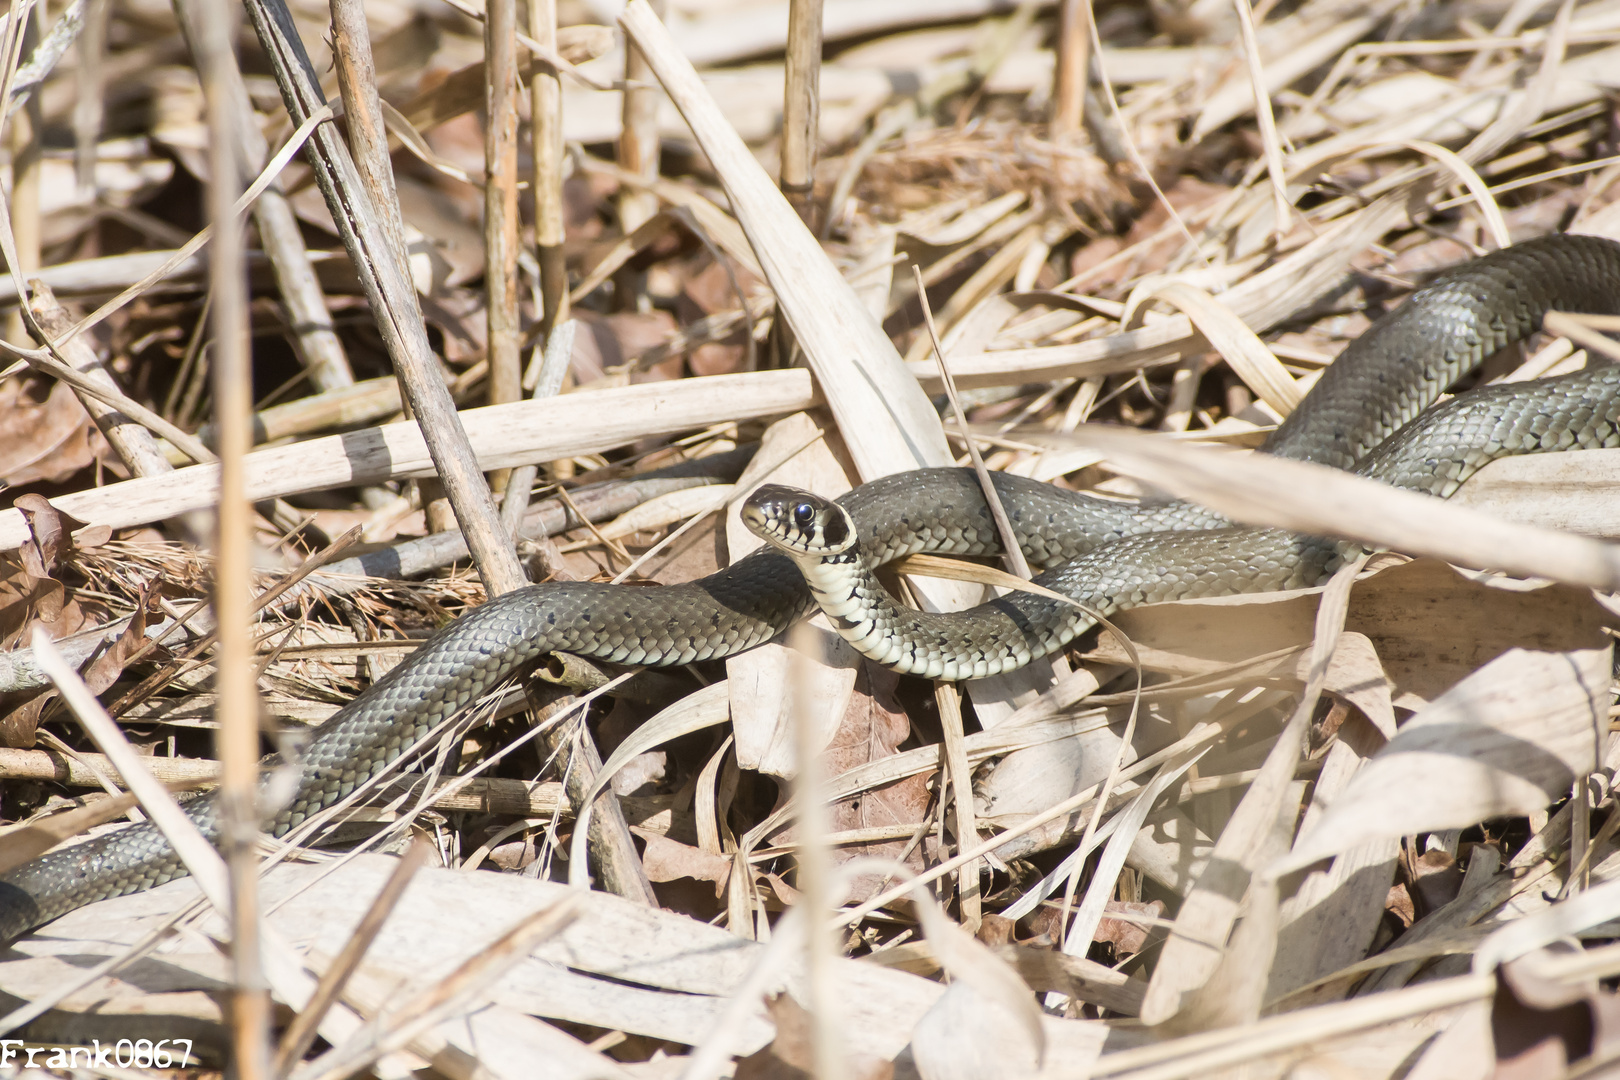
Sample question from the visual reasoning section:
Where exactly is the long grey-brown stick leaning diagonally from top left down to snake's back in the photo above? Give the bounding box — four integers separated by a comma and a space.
248, 0, 525, 596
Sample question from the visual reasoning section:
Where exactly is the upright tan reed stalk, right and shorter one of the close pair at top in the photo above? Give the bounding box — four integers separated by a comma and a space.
528, 0, 569, 338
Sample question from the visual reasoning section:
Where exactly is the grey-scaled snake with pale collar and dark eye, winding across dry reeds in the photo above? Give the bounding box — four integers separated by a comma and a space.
0, 235, 1620, 941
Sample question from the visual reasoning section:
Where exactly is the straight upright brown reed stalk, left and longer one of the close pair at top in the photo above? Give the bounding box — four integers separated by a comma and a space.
484, 0, 523, 472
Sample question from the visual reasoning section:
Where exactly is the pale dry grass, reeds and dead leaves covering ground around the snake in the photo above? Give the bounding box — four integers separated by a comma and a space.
0, 0, 1620, 1080
